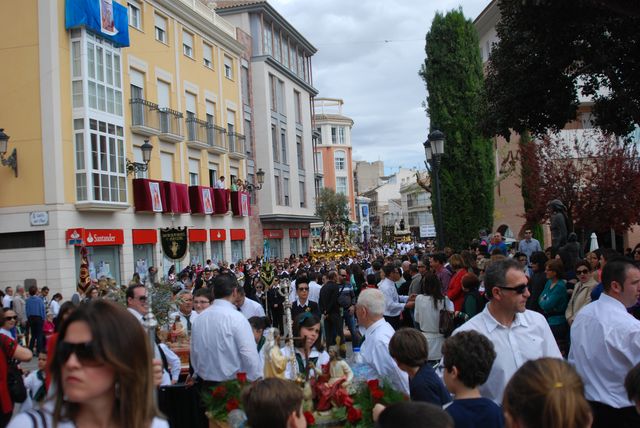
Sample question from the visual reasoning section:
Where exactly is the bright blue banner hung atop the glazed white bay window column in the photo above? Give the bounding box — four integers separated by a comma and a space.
65, 0, 129, 48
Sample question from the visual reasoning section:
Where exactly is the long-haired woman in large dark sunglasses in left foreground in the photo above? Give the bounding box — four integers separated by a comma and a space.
9, 300, 168, 428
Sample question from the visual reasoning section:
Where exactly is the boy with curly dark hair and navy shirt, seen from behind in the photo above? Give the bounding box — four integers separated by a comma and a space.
442, 331, 504, 428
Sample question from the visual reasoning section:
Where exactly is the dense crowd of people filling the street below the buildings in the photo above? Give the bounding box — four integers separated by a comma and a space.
0, 230, 640, 428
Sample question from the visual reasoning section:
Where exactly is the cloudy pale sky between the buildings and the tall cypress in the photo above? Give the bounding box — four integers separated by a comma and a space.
268, 0, 490, 173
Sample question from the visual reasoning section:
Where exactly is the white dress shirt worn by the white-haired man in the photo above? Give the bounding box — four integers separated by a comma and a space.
360, 318, 409, 396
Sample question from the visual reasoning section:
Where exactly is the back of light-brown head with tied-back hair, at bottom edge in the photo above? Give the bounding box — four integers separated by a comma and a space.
502, 358, 593, 428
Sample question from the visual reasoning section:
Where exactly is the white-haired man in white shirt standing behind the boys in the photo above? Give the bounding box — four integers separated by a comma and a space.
355, 288, 409, 395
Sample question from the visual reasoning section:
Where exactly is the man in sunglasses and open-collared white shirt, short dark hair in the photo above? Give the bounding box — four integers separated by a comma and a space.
454, 259, 562, 404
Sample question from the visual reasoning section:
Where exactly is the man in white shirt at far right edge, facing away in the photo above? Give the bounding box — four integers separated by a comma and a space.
569, 260, 640, 427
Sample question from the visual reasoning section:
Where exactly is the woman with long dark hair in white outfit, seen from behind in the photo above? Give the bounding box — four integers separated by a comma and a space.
413, 272, 454, 361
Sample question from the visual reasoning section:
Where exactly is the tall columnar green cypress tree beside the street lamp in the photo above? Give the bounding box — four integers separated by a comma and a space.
419, 9, 494, 248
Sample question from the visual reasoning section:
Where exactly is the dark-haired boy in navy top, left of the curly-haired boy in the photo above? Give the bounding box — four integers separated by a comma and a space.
389, 328, 450, 407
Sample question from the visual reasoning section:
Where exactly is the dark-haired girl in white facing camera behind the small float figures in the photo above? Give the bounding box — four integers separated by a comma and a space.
282, 312, 330, 380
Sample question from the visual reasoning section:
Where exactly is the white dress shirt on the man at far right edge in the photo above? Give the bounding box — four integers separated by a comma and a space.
569, 293, 640, 409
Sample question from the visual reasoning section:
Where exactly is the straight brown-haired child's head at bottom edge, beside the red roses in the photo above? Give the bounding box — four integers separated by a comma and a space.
242, 377, 307, 428
